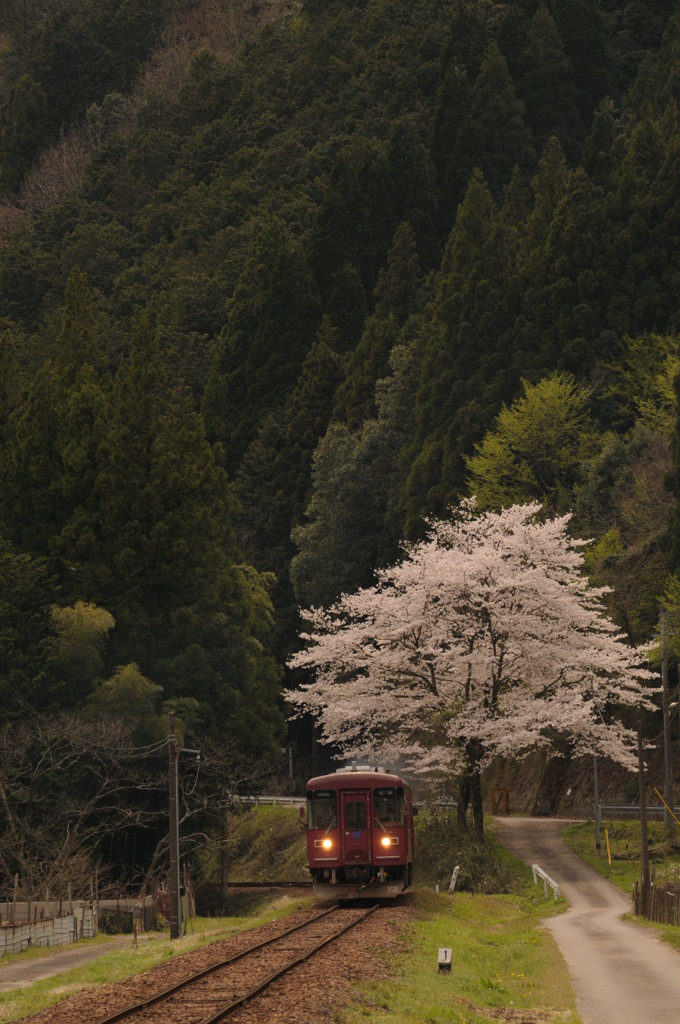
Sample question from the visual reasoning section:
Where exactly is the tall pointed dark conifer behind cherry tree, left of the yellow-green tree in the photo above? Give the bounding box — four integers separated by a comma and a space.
407, 172, 518, 534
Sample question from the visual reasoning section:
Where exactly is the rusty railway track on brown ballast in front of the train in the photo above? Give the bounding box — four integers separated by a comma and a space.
93, 904, 379, 1024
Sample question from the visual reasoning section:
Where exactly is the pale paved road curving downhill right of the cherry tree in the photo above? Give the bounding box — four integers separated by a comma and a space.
500, 818, 680, 1024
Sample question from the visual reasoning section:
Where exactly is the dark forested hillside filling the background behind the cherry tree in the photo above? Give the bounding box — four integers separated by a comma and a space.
0, 0, 680, 811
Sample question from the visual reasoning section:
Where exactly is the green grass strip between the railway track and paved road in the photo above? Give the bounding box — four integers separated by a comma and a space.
338, 890, 581, 1024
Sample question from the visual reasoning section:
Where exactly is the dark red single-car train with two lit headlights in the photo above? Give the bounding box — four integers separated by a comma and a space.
307, 765, 414, 899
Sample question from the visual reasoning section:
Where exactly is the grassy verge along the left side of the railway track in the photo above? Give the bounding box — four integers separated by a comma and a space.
0, 896, 308, 1024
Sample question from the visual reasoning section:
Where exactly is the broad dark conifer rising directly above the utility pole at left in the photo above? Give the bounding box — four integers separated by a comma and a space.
89, 327, 281, 753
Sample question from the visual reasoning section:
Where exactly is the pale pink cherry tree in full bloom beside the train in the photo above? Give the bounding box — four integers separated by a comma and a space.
287, 499, 653, 834
